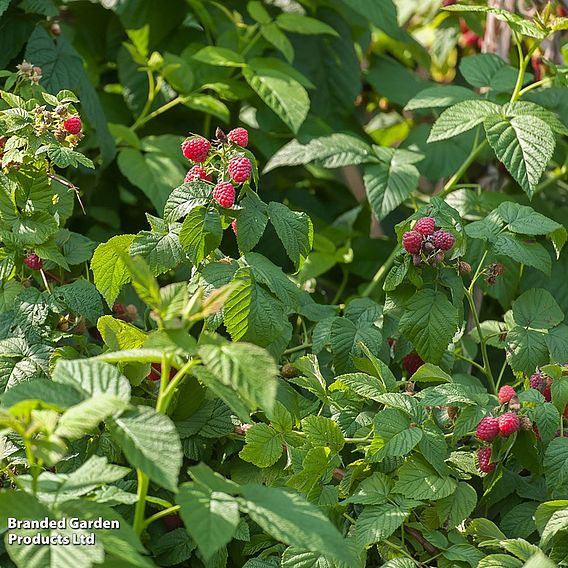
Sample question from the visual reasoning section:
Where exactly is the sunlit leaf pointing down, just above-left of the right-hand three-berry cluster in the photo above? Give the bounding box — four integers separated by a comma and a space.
363, 148, 420, 220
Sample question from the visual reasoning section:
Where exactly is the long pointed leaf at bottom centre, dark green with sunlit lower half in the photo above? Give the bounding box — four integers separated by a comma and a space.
241, 485, 357, 566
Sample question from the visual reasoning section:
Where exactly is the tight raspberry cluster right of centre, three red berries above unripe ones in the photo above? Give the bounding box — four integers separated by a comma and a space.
402, 217, 456, 266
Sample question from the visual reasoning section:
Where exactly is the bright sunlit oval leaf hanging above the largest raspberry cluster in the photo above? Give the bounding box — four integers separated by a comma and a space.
243, 64, 310, 134
